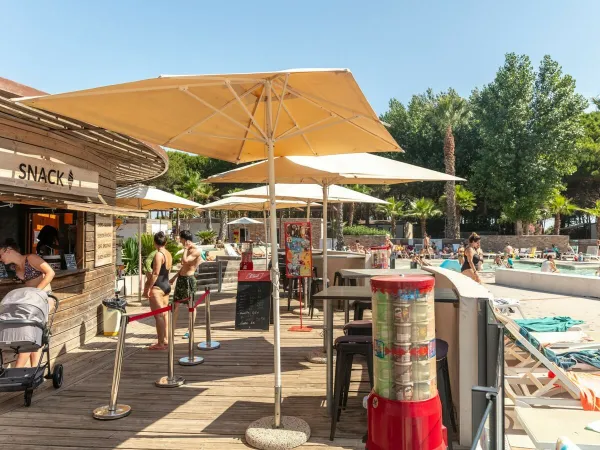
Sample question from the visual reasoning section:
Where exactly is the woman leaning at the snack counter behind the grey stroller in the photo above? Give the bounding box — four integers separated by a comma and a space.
0, 239, 56, 368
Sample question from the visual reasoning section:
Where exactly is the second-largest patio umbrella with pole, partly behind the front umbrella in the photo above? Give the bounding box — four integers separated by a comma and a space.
207, 153, 464, 412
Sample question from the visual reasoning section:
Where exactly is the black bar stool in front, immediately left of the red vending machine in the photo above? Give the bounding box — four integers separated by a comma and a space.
329, 336, 373, 441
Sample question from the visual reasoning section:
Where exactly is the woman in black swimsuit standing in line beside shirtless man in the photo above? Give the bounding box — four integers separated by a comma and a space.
144, 231, 173, 350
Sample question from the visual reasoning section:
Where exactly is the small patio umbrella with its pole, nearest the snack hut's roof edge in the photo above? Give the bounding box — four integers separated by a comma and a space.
116, 184, 202, 301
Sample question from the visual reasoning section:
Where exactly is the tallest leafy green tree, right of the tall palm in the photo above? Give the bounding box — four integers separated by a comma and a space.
470, 53, 587, 232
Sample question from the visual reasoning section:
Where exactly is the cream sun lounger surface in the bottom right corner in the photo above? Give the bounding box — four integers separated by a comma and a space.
515, 408, 600, 450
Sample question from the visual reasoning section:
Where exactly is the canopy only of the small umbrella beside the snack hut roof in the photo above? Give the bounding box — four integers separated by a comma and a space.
117, 184, 202, 211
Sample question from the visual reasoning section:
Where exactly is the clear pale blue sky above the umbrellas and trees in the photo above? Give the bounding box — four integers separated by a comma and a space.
0, 0, 600, 113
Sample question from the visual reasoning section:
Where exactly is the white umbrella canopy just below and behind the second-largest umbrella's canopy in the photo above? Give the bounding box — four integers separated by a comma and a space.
223, 183, 387, 205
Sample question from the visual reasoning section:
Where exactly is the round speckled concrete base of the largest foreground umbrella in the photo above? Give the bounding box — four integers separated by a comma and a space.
246, 416, 310, 450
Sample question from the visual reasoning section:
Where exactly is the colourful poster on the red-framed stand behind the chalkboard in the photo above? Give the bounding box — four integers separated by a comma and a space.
285, 222, 312, 278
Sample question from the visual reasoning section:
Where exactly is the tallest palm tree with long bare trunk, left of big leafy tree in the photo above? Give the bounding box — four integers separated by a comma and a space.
432, 89, 470, 239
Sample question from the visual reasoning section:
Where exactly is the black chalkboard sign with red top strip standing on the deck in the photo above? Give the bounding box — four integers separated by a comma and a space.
235, 270, 272, 330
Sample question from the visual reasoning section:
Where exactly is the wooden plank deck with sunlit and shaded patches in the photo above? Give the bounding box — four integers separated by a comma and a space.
0, 293, 368, 450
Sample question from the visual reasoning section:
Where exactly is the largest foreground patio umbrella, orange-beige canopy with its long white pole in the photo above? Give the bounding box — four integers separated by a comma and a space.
15, 69, 401, 445
